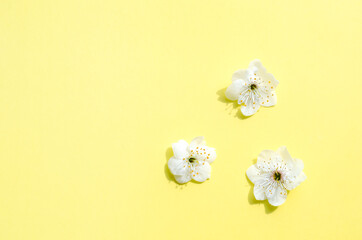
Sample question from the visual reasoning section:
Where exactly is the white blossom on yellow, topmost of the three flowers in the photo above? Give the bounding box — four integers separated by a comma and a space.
225, 60, 279, 116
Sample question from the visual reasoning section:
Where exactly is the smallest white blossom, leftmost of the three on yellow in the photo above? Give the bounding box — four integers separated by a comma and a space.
168, 137, 216, 183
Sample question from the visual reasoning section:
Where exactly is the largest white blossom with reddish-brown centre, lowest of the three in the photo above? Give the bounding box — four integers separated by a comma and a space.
246, 147, 307, 206
